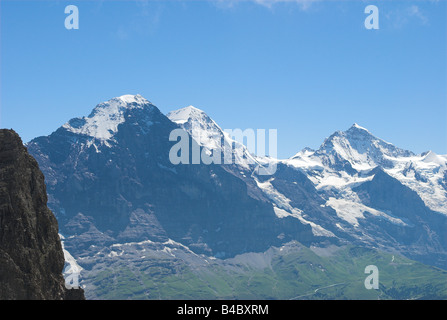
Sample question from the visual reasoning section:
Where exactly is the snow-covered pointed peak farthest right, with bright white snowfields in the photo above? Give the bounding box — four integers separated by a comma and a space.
286, 124, 447, 214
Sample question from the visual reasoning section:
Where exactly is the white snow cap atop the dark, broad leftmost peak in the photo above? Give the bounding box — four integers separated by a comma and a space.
62, 94, 154, 140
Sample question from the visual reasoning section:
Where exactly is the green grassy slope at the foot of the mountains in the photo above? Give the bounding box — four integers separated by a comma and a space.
87, 246, 447, 299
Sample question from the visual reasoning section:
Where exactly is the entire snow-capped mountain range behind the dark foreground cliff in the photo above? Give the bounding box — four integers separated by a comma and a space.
26, 95, 447, 299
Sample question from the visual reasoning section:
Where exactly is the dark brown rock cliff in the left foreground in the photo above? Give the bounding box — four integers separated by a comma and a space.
0, 129, 84, 300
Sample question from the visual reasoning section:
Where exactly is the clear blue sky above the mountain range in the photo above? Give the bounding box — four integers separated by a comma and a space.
0, 0, 447, 158
